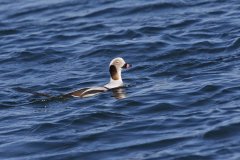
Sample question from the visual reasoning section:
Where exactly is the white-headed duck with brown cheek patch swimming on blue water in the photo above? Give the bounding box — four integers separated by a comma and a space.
67, 57, 132, 98
